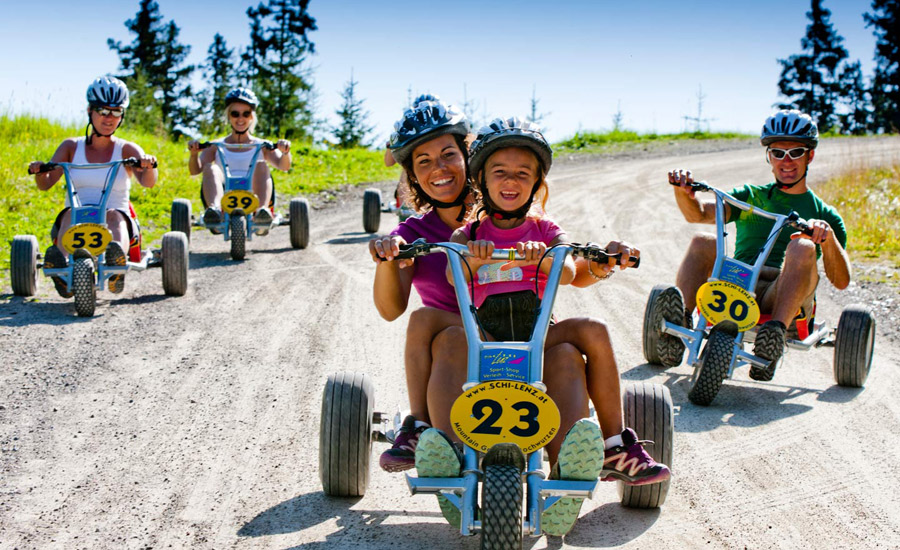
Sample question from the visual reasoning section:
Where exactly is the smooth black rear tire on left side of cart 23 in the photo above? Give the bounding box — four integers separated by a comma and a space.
319, 372, 375, 497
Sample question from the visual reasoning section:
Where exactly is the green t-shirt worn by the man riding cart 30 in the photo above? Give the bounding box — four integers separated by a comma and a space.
727, 182, 847, 268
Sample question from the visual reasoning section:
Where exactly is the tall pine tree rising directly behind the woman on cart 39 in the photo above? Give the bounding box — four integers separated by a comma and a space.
242, 0, 317, 138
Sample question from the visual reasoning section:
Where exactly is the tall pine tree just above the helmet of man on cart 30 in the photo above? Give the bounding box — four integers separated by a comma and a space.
778, 0, 847, 132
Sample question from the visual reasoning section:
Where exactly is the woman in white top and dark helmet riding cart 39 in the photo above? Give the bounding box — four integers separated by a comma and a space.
188, 88, 291, 227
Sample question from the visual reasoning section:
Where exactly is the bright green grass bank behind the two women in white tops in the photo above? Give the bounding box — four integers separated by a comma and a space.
0, 115, 399, 288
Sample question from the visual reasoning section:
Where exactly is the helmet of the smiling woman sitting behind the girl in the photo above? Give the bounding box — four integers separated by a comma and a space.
388, 101, 469, 164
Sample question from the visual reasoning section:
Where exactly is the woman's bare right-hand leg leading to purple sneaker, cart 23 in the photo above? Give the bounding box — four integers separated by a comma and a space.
547, 317, 625, 437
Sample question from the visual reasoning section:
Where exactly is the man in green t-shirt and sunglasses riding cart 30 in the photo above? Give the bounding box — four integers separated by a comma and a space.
660, 110, 850, 380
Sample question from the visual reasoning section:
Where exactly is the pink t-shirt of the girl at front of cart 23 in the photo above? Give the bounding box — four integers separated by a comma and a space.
465, 217, 565, 307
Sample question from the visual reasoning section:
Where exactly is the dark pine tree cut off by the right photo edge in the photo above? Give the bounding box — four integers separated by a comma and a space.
863, 0, 900, 133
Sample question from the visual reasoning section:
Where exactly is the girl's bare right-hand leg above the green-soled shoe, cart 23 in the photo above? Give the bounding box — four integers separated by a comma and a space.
544, 344, 589, 464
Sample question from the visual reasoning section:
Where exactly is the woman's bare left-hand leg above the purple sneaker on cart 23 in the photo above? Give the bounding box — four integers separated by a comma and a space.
404, 307, 466, 424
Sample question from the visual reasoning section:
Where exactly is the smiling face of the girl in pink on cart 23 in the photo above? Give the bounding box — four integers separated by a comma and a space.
484, 147, 540, 212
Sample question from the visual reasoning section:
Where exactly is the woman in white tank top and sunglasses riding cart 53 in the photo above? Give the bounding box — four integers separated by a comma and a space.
29, 76, 157, 297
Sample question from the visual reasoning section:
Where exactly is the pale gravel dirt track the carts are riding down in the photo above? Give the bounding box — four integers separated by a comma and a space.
0, 139, 900, 550
